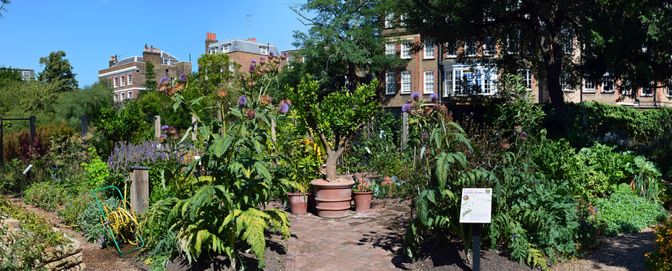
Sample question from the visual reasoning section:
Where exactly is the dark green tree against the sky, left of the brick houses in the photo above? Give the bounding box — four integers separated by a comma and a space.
38, 51, 78, 92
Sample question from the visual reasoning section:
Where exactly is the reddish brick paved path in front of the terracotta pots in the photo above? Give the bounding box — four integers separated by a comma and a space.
286, 207, 409, 271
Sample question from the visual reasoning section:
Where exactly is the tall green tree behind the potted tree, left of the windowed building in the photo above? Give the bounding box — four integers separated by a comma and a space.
294, 0, 405, 93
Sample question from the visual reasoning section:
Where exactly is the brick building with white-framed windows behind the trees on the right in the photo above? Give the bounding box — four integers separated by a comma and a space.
380, 15, 672, 107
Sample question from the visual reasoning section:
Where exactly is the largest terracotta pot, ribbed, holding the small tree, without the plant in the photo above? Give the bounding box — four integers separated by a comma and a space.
310, 179, 355, 218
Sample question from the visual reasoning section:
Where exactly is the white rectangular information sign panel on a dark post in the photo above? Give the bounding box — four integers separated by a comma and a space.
460, 188, 492, 223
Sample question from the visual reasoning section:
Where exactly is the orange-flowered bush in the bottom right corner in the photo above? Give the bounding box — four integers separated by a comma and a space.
644, 219, 672, 271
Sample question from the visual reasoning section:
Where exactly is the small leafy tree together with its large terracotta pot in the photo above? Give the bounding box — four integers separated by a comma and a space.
290, 76, 379, 218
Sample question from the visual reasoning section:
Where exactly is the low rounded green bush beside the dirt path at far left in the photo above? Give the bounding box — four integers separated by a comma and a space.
23, 181, 68, 214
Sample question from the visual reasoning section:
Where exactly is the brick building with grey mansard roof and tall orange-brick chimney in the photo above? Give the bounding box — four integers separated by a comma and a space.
205, 32, 279, 72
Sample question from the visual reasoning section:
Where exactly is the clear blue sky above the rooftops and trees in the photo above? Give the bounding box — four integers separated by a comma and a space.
0, 0, 307, 87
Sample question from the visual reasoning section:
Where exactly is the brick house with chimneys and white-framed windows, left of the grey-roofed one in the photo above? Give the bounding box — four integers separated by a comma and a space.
98, 45, 191, 102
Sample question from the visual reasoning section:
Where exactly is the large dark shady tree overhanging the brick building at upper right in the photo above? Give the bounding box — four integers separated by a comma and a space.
391, 0, 672, 106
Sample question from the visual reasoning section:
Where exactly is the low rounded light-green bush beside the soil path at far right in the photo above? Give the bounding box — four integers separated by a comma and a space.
595, 184, 667, 235
